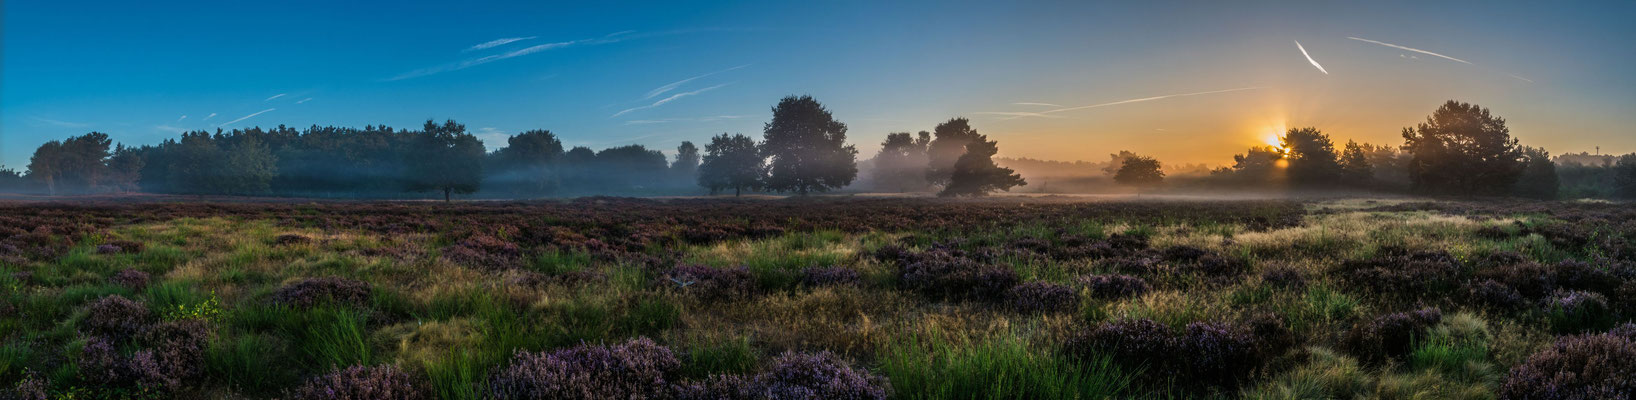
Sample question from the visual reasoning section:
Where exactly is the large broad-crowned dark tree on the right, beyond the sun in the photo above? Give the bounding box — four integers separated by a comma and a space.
1404, 100, 1523, 195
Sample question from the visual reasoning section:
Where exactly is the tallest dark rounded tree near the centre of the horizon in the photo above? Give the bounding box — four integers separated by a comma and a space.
761, 95, 857, 195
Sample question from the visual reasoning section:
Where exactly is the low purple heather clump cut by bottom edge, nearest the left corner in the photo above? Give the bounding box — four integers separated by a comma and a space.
291, 366, 432, 400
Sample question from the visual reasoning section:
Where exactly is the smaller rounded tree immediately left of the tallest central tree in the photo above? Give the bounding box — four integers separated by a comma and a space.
699, 133, 767, 197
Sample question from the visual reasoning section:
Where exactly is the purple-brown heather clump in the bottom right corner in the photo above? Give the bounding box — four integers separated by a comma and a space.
1499, 326, 1636, 400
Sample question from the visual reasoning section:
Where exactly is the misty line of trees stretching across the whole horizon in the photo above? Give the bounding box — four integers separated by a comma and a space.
0, 97, 1636, 200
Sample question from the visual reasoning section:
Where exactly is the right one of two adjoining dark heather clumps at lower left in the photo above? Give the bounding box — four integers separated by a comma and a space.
131, 320, 211, 389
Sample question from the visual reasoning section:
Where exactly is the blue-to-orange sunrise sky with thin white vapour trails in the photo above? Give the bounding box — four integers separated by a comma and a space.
0, 0, 1636, 169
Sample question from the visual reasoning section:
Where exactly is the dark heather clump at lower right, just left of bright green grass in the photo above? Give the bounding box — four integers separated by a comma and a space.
1342, 308, 1443, 362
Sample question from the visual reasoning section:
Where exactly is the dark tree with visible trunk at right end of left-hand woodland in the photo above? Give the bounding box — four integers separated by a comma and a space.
404, 120, 483, 202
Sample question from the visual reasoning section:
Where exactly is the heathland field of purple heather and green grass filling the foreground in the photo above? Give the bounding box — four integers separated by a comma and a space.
0, 198, 1636, 400
